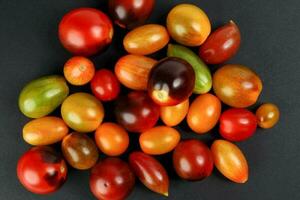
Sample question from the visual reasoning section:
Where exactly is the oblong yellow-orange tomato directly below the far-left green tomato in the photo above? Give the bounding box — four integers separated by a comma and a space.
23, 117, 69, 145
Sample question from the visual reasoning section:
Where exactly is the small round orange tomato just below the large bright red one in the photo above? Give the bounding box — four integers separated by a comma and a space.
64, 56, 95, 85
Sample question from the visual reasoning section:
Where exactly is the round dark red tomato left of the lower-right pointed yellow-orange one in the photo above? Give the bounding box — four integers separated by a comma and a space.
173, 139, 214, 180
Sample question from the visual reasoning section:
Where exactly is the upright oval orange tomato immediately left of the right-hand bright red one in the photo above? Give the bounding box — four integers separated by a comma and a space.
187, 94, 222, 134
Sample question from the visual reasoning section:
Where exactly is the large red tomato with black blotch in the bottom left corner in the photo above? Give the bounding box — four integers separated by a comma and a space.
17, 146, 67, 194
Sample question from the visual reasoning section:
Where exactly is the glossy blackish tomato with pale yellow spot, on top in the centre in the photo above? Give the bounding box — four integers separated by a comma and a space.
148, 57, 195, 106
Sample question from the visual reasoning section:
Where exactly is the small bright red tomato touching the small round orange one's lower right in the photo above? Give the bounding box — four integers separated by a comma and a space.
91, 69, 120, 101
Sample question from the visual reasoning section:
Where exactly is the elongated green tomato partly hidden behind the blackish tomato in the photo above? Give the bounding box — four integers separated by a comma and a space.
168, 44, 212, 94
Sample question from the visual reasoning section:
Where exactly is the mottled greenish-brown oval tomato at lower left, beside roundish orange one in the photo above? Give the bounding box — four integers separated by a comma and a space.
61, 132, 99, 170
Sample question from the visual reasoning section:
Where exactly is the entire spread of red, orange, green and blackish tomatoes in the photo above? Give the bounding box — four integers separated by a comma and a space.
17, 0, 279, 200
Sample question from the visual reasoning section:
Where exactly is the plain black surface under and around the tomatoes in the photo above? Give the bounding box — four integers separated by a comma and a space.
0, 0, 300, 200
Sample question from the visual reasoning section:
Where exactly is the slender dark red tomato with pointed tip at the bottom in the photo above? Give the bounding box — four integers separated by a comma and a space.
129, 152, 169, 196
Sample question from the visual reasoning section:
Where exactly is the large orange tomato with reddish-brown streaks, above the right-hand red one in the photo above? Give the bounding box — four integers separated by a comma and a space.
213, 65, 262, 108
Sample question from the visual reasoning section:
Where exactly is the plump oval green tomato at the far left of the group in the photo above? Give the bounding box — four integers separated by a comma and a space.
19, 75, 69, 118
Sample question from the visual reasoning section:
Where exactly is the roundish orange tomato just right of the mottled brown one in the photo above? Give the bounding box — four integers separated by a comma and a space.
95, 122, 129, 156
